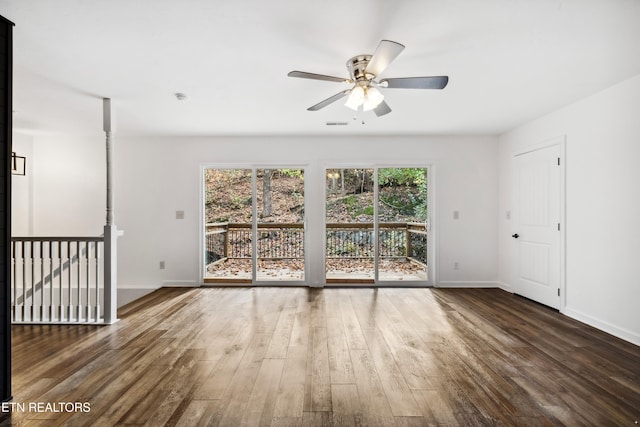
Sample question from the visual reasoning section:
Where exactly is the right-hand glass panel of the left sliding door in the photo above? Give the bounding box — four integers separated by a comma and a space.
256, 169, 305, 281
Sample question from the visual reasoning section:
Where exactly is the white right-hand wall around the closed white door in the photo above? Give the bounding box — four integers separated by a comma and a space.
499, 76, 640, 344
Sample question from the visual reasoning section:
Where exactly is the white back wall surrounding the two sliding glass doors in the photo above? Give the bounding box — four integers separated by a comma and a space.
18, 134, 498, 302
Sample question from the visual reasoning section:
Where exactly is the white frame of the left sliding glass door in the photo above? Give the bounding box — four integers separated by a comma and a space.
198, 163, 309, 287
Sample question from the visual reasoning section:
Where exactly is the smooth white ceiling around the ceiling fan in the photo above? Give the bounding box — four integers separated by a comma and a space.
0, 0, 640, 135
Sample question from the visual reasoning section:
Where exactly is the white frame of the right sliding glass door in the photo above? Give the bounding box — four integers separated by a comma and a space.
321, 161, 437, 288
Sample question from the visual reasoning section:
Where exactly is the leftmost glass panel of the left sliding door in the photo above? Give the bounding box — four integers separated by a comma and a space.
204, 169, 253, 283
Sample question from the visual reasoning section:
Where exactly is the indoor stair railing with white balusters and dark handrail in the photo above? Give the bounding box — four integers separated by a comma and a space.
11, 237, 105, 323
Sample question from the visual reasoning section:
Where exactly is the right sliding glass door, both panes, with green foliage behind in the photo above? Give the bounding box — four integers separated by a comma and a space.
325, 167, 429, 285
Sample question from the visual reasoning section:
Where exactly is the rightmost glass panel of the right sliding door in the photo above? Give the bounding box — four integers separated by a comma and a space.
377, 168, 428, 282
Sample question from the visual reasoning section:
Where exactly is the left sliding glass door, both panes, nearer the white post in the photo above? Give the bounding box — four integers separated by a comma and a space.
203, 168, 305, 284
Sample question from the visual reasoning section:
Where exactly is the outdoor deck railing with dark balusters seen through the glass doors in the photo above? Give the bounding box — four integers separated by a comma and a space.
205, 222, 428, 265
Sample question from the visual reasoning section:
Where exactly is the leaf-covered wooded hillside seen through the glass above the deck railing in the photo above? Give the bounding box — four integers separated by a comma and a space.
205, 168, 427, 223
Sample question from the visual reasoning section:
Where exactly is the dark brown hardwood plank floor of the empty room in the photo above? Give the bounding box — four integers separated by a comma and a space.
0, 288, 640, 426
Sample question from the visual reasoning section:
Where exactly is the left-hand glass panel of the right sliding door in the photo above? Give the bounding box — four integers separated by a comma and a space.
325, 168, 375, 283
